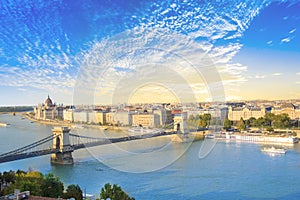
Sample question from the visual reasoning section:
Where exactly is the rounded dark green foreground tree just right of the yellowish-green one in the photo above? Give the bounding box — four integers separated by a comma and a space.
41, 173, 64, 198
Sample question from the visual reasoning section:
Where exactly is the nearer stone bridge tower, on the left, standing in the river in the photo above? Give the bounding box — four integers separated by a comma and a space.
51, 127, 74, 165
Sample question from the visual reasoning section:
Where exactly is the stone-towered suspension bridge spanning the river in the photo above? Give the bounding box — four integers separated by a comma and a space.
0, 115, 202, 164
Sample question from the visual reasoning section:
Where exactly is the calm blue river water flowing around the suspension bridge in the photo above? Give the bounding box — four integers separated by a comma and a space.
0, 114, 300, 199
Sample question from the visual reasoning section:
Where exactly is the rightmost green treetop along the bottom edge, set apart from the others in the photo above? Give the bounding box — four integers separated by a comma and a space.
100, 183, 134, 200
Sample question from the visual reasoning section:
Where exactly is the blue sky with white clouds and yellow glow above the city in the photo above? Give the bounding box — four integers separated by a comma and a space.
0, 0, 300, 106
